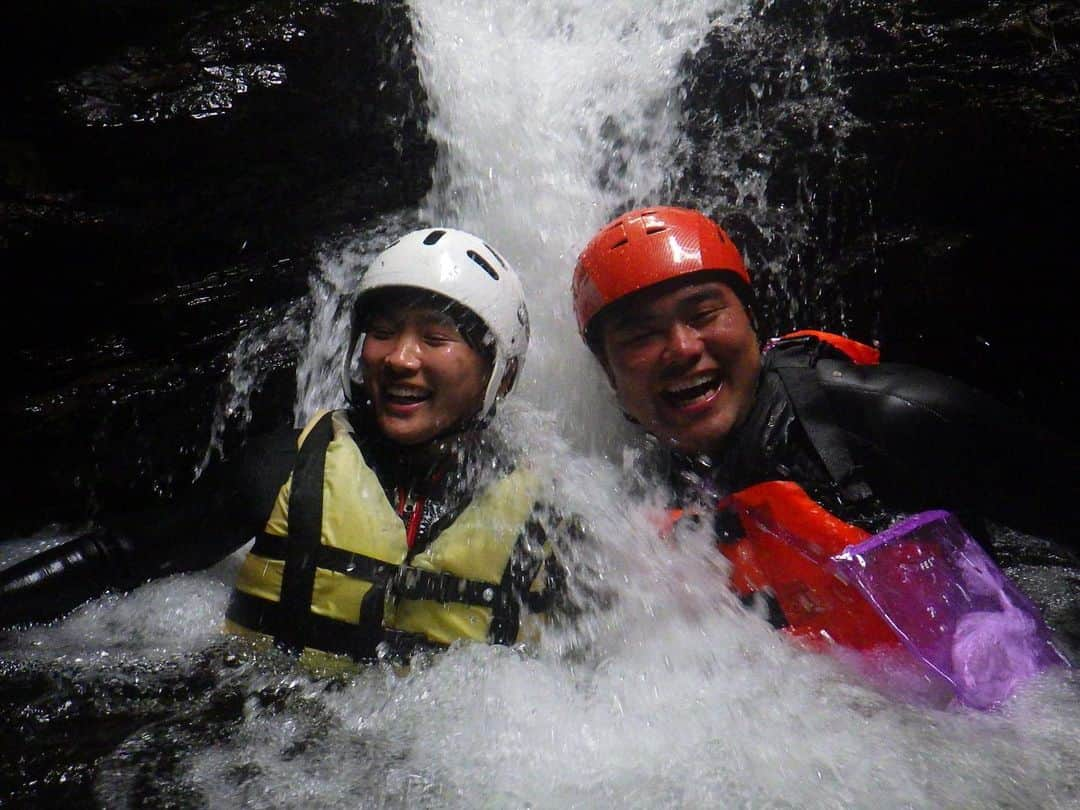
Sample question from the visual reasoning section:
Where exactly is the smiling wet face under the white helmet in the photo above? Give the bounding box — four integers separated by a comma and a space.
360, 307, 490, 446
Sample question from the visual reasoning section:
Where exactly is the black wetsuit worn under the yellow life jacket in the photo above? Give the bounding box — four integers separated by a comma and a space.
0, 414, 562, 648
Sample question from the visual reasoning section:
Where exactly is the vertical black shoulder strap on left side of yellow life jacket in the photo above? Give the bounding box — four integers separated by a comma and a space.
273, 414, 334, 652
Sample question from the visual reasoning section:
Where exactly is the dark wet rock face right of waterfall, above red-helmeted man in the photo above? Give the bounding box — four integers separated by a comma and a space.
683, 0, 1080, 436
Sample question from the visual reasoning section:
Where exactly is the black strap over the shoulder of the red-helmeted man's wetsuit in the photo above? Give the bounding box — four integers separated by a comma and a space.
764, 336, 872, 503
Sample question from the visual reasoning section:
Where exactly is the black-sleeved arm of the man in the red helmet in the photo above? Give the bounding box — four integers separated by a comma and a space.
818, 361, 1078, 552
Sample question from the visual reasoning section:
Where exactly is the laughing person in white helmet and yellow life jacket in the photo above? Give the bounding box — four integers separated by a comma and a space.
0, 228, 565, 660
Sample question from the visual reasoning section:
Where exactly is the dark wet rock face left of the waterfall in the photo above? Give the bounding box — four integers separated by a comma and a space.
0, 0, 434, 535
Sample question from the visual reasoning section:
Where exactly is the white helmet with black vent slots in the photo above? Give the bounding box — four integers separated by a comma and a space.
342, 228, 529, 416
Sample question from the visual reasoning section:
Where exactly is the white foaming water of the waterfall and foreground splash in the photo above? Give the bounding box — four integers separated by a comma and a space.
8, 0, 1080, 808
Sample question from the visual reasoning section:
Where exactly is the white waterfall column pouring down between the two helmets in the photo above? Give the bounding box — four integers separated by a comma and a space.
410, 0, 746, 457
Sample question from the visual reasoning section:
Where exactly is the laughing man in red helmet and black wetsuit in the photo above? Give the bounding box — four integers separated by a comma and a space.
573, 206, 1077, 678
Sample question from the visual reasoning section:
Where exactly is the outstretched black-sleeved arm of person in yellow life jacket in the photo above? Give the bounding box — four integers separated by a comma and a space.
0, 430, 296, 626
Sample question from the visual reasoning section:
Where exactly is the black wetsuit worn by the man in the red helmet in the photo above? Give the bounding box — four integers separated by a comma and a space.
671, 337, 1080, 553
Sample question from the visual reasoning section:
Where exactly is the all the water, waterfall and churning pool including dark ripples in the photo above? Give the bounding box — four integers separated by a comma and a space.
0, 0, 1080, 809
